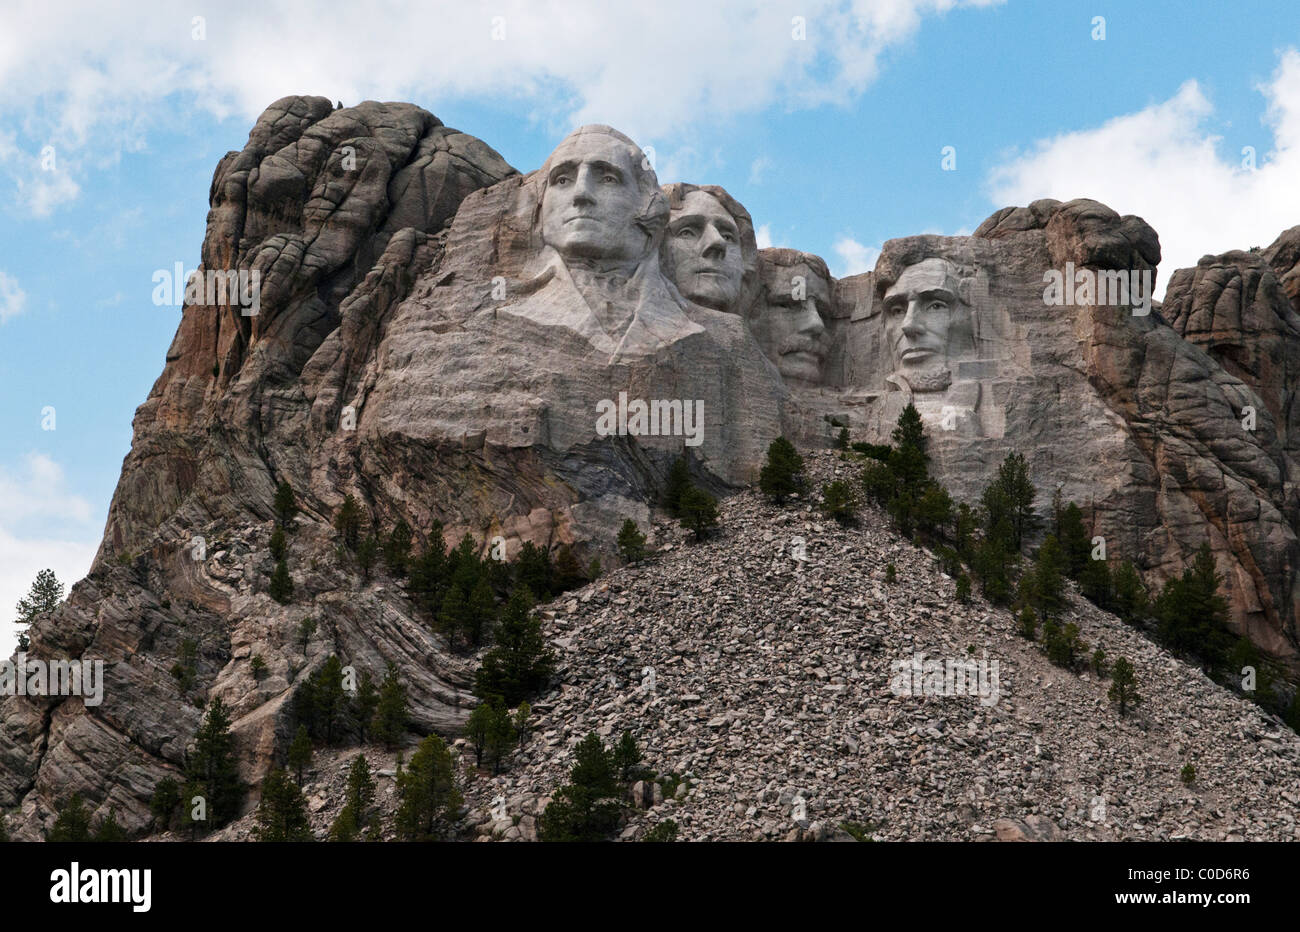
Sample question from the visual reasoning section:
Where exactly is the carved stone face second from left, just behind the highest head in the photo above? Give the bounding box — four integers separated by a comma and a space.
668, 191, 745, 311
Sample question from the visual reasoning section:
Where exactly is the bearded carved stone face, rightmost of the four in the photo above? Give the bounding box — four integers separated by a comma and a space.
883, 259, 961, 387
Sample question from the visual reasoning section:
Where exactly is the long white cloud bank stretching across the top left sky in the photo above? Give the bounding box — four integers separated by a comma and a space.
0, 0, 1000, 212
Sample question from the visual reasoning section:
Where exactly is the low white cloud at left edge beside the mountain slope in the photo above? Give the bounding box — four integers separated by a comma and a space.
0, 454, 100, 656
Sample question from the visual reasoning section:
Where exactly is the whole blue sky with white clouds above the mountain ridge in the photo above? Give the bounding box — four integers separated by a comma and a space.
0, 0, 1300, 645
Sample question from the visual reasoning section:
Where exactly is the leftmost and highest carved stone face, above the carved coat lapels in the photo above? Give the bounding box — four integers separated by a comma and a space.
541, 133, 647, 260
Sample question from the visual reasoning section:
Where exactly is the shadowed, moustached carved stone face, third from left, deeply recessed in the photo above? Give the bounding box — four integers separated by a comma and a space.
750, 264, 829, 383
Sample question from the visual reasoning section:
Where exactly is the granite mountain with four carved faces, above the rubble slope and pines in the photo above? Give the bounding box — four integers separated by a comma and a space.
0, 96, 1300, 825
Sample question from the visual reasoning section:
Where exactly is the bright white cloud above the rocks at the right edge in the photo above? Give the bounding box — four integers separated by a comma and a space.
989, 48, 1300, 292
